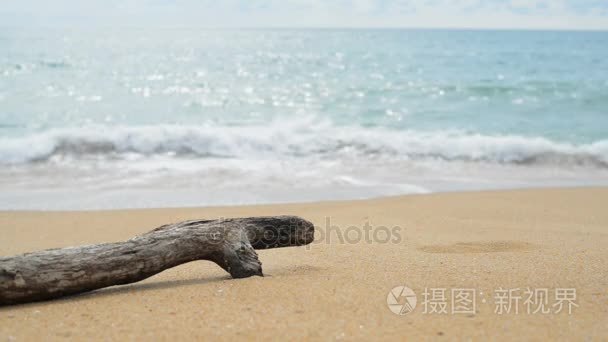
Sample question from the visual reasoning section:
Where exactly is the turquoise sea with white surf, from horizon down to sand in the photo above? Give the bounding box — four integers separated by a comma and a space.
0, 28, 608, 209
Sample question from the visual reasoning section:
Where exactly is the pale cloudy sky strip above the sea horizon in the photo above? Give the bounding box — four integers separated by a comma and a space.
0, 0, 608, 30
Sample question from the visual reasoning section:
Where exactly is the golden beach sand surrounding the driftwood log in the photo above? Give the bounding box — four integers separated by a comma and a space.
0, 188, 608, 341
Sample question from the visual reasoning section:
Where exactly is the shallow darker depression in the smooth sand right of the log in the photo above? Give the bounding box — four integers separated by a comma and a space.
418, 241, 538, 254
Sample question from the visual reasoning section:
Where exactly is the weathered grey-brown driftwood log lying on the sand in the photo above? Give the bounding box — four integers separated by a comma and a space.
0, 216, 314, 305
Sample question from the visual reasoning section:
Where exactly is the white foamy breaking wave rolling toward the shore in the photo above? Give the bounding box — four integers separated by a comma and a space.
0, 120, 608, 168
